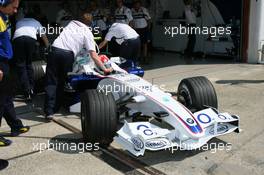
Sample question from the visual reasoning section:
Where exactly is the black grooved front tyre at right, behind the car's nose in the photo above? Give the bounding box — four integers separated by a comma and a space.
178, 77, 218, 111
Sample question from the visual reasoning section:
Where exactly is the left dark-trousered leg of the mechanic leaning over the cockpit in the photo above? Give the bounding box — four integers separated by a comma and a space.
44, 51, 58, 117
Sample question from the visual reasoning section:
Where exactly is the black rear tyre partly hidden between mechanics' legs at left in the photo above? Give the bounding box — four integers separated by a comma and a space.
32, 61, 46, 93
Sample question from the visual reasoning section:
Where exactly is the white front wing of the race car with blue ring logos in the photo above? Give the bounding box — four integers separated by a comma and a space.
114, 108, 239, 156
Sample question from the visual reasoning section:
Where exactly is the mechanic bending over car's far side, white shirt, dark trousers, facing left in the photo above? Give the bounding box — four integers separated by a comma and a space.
99, 23, 141, 62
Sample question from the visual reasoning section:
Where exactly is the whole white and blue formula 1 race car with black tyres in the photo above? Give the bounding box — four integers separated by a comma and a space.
32, 54, 239, 156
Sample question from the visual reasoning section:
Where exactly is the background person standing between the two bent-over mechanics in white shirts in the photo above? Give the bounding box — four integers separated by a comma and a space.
90, 1, 107, 37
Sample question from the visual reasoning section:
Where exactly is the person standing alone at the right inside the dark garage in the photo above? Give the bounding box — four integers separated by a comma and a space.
183, 0, 196, 57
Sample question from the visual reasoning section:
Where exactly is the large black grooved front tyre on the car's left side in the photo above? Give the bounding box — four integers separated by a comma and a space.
81, 90, 117, 146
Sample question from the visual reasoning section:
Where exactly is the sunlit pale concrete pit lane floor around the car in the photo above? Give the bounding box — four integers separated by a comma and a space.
0, 53, 264, 175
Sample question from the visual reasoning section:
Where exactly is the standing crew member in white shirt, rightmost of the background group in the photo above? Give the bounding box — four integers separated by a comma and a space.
132, 0, 151, 63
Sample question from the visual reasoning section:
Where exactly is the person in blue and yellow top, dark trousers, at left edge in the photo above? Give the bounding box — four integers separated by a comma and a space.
0, 0, 29, 147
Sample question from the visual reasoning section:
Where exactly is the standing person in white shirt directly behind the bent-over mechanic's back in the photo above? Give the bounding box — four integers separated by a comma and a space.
115, 0, 133, 26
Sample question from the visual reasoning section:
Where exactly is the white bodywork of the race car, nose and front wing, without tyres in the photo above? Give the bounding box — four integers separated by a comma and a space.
70, 57, 239, 156
